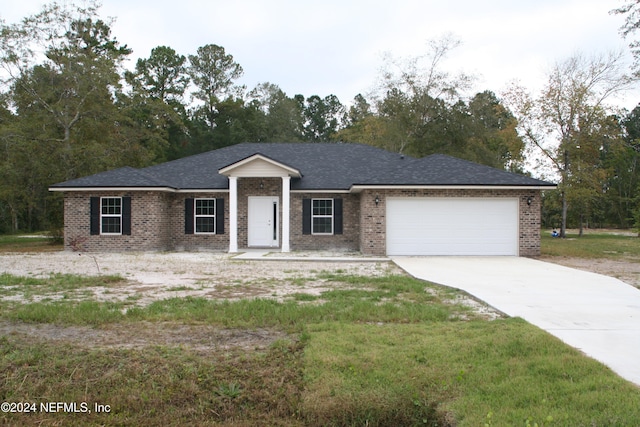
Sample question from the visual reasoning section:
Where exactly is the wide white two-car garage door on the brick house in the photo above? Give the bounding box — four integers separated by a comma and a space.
387, 198, 518, 255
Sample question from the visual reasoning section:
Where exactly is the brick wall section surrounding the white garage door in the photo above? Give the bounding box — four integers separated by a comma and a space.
360, 190, 541, 256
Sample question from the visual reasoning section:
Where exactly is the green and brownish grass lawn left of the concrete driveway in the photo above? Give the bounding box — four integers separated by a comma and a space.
0, 272, 640, 426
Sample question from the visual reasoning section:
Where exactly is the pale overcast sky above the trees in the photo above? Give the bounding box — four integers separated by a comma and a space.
0, 0, 639, 107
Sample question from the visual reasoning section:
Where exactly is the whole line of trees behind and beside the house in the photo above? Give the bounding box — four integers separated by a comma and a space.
0, 2, 640, 237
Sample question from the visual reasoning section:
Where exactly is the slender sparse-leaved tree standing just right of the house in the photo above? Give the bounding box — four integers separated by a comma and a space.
507, 53, 634, 237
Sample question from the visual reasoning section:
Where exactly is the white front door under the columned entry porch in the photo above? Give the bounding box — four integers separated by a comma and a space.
247, 196, 279, 248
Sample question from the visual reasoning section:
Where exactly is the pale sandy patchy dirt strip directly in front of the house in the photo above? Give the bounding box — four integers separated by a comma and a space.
0, 252, 401, 306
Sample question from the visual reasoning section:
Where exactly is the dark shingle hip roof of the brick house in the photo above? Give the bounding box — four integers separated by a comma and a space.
52, 143, 554, 190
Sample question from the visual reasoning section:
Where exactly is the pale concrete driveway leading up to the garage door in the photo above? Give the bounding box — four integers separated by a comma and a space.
392, 257, 640, 385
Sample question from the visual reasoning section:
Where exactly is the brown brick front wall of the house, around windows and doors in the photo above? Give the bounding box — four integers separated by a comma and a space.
64, 186, 541, 256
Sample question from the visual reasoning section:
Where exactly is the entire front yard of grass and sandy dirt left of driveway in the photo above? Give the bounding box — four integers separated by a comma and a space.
0, 236, 640, 426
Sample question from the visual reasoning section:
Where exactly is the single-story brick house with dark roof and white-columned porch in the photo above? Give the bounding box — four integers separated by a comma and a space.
50, 143, 556, 256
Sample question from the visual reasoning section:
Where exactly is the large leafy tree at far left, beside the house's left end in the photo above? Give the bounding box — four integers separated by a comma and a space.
0, 1, 148, 229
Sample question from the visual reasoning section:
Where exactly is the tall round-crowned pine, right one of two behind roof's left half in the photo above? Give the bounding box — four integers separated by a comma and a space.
188, 44, 243, 130
